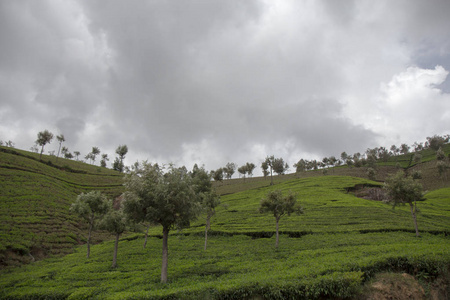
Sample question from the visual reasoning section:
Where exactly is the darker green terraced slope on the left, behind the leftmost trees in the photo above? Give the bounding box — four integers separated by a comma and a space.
0, 147, 123, 266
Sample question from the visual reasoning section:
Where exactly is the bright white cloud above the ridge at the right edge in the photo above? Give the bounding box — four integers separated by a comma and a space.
348, 66, 450, 145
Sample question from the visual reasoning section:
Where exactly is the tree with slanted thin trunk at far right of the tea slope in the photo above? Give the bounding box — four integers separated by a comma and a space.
384, 171, 422, 236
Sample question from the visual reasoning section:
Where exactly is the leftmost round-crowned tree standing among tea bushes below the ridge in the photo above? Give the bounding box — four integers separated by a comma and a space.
70, 191, 108, 258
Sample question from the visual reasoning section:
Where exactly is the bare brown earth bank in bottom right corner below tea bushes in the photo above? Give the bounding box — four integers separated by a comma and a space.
357, 273, 450, 300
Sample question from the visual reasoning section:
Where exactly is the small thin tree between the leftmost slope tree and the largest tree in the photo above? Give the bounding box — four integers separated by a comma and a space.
99, 202, 127, 268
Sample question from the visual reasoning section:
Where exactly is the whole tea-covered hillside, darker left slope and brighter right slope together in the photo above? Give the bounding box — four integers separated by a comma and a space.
0, 147, 450, 299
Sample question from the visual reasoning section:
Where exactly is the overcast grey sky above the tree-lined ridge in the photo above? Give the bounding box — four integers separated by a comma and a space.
0, 0, 450, 174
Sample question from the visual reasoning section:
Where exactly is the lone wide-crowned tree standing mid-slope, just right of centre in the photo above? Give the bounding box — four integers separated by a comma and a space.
259, 190, 303, 248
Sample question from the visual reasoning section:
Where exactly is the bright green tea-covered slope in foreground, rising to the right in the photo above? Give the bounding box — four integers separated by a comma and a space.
0, 176, 450, 299
